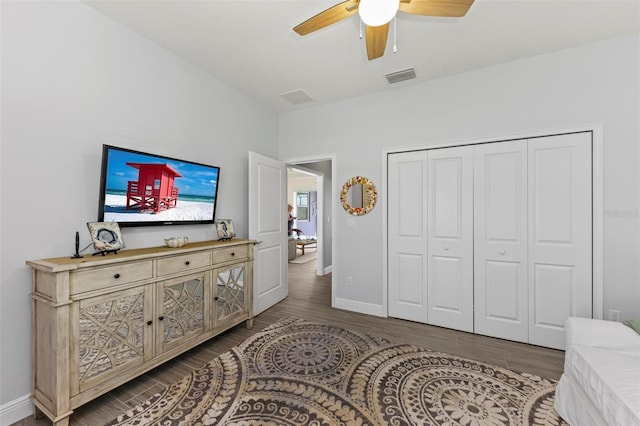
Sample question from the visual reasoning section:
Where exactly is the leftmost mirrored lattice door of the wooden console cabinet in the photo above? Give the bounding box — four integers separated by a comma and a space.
70, 285, 153, 395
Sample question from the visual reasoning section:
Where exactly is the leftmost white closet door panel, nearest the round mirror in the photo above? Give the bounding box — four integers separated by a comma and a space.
387, 151, 428, 323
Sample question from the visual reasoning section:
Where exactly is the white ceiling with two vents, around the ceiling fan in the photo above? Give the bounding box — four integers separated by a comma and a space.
86, 0, 640, 112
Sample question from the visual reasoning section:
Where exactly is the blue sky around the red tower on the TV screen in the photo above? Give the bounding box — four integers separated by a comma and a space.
107, 149, 218, 197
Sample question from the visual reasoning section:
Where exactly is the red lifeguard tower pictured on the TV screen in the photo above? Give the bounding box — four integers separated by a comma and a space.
126, 162, 182, 213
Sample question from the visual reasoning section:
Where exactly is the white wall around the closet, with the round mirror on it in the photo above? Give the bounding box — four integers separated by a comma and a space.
280, 35, 640, 319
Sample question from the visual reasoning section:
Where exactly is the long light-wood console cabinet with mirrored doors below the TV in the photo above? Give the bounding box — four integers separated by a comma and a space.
27, 239, 253, 426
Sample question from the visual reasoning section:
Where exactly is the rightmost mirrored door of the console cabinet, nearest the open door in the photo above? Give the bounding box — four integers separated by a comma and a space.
214, 263, 247, 326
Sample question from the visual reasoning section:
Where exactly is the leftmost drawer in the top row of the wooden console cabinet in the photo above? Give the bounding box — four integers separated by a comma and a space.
69, 260, 153, 294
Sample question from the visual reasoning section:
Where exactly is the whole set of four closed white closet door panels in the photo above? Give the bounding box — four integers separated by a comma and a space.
387, 132, 593, 349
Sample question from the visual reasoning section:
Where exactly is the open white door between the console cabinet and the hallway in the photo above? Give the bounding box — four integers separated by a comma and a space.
248, 152, 289, 315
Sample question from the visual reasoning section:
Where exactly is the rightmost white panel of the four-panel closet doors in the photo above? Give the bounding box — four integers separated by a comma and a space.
528, 133, 592, 349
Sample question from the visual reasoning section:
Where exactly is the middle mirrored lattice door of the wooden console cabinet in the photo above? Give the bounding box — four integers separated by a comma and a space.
155, 272, 211, 353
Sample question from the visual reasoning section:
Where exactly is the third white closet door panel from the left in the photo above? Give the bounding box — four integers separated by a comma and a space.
474, 140, 529, 342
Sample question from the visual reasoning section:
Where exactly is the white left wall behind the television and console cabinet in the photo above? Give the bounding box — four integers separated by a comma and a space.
0, 1, 278, 412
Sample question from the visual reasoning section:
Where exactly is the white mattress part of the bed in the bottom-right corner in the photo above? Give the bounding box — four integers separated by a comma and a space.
556, 345, 640, 426
